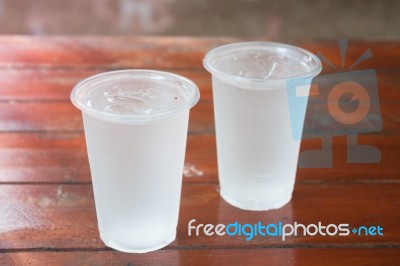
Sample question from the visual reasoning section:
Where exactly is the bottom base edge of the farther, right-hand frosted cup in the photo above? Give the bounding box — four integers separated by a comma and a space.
220, 189, 292, 211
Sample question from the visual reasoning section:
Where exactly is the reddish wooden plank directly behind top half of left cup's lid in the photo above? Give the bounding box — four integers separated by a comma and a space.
0, 68, 400, 103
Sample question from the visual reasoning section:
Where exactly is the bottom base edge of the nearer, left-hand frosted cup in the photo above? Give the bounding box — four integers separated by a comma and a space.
100, 231, 176, 253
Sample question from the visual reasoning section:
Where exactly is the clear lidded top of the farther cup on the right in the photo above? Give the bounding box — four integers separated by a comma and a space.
203, 42, 322, 89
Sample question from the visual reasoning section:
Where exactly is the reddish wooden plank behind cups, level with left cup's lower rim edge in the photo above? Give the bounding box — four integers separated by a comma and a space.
0, 101, 400, 134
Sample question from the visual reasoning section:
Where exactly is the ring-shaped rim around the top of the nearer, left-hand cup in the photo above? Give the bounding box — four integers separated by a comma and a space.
70, 69, 200, 124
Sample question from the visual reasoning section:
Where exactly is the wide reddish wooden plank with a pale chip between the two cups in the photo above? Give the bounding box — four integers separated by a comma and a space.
0, 132, 400, 183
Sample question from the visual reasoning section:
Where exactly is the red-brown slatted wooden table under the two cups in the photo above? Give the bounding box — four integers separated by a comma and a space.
0, 36, 400, 265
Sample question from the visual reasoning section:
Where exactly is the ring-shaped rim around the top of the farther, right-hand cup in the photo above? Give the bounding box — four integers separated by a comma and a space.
203, 41, 322, 88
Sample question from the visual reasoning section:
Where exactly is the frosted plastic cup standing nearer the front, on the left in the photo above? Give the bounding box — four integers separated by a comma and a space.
71, 70, 200, 253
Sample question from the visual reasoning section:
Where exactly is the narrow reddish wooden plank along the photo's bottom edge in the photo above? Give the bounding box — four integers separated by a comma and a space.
0, 248, 400, 266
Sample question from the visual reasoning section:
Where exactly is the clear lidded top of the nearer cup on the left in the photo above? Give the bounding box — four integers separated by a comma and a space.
71, 69, 200, 124
